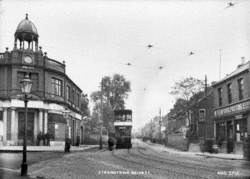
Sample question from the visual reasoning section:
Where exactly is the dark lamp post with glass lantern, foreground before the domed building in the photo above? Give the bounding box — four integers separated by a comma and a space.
20, 75, 32, 176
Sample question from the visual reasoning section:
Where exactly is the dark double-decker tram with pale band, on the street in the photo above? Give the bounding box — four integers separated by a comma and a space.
114, 109, 132, 149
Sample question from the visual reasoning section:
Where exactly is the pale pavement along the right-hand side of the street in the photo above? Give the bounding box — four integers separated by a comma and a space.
146, 142, 244, 160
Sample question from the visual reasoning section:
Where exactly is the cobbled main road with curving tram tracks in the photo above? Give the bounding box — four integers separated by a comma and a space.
24, 140, 250, 179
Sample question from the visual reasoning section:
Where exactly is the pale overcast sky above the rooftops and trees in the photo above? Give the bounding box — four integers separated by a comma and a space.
0, 0, 250, 129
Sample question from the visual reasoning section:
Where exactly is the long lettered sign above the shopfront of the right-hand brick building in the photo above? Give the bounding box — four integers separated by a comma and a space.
214, 101, 250, 117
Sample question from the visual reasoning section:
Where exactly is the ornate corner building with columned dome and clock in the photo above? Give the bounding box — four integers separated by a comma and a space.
0, 14, 83, 145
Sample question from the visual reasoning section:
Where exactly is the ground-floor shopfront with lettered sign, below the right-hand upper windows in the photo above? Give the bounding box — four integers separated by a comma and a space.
215, 101, 250, 154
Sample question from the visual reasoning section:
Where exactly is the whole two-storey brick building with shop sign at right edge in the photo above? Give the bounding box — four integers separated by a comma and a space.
213, 62, 250, 154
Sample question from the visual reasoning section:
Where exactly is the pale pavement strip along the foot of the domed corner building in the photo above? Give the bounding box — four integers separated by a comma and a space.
0, 145, 98, 152
